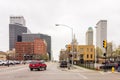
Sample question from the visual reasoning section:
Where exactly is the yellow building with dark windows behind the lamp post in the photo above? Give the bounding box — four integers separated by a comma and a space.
66, 45, 95, 63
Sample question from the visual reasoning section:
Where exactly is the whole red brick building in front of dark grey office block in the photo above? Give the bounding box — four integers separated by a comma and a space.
15, 38, 47, 60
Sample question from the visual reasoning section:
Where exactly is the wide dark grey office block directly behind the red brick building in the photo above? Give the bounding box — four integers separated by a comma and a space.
22, 33, 51, 60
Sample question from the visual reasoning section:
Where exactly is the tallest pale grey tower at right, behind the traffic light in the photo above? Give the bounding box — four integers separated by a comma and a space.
96, 20, 107, 52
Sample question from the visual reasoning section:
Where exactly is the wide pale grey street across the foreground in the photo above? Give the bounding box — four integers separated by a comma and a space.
0, 62, 120, 80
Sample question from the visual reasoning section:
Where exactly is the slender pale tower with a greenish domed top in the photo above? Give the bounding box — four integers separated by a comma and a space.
86, 27, 93, 45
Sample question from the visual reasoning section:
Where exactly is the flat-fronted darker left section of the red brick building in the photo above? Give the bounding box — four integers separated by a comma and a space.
15, 42, 34, 60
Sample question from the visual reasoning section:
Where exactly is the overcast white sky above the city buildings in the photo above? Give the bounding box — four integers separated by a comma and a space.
0, 0, 120, 59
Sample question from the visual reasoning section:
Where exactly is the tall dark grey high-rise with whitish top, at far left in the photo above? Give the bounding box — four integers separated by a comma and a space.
9, 16, 27, 50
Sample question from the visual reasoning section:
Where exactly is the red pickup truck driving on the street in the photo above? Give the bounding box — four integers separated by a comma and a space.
29, 61, 47, 71
